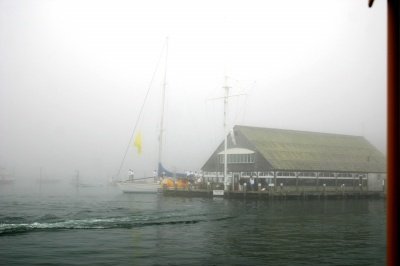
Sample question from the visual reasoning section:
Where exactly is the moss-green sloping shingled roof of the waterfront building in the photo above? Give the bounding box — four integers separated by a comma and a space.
234, 126, 386, 173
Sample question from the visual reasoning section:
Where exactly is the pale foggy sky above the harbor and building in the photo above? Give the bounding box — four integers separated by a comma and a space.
0, 0, 386, 182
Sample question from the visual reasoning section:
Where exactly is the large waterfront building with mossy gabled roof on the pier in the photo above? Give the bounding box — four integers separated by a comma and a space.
202, 126, 386, 191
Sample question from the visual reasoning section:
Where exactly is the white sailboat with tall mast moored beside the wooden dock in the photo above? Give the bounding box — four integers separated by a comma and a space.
116, 38, 169, 193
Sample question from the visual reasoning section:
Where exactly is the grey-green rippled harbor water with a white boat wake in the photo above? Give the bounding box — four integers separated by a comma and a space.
0, 184, 386, 265
